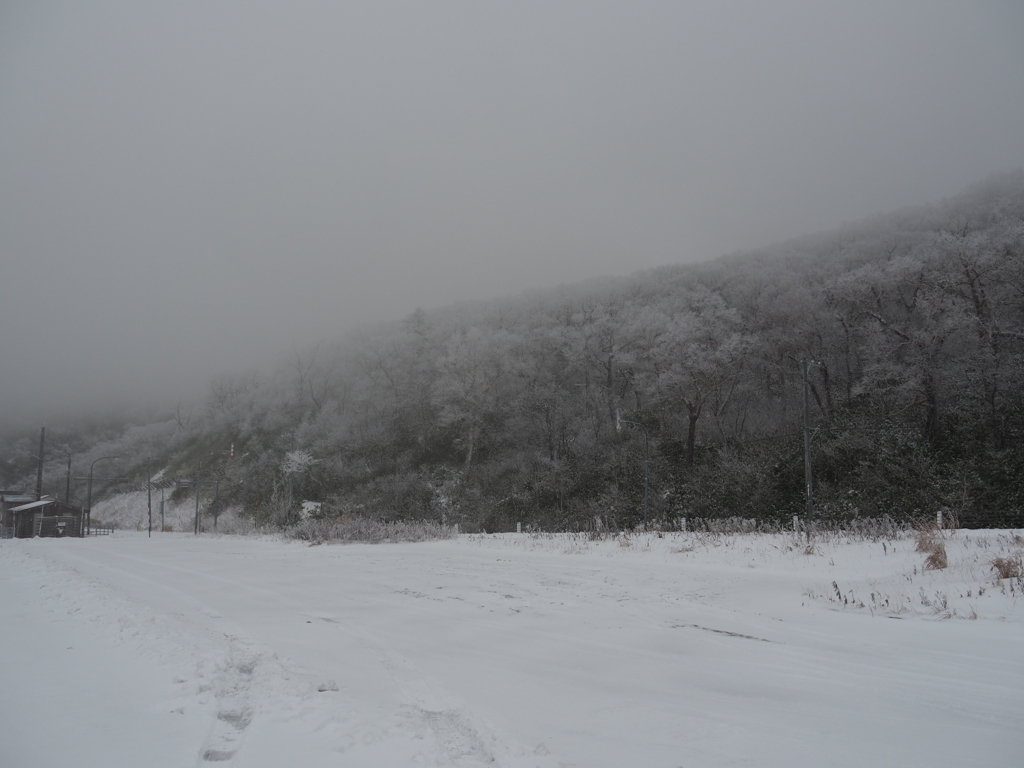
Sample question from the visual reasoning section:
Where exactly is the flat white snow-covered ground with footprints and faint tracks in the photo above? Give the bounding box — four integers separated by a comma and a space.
0, 531, 1024, 768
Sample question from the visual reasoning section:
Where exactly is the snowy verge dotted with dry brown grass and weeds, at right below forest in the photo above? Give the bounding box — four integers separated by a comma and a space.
469, 527, 1024, 620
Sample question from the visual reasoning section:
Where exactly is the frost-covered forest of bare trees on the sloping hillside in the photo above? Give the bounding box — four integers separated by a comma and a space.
3, 171, 1024, 531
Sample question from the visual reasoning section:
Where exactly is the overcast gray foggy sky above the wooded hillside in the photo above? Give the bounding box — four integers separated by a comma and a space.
0, 0, 1024, 422
